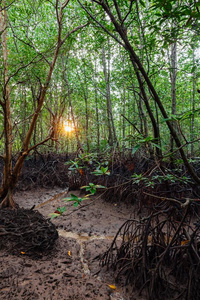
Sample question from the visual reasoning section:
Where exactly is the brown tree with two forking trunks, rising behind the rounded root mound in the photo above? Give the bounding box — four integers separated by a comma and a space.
0, 1, 86, 208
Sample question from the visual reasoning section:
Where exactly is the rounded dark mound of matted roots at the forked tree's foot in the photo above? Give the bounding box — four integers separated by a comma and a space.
0, 208, 58, 255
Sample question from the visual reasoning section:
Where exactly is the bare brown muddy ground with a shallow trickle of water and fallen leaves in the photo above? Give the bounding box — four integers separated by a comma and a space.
0, 188, 144, 300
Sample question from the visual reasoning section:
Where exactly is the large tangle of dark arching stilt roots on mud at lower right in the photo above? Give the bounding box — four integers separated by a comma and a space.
100, 205, 200, 300
